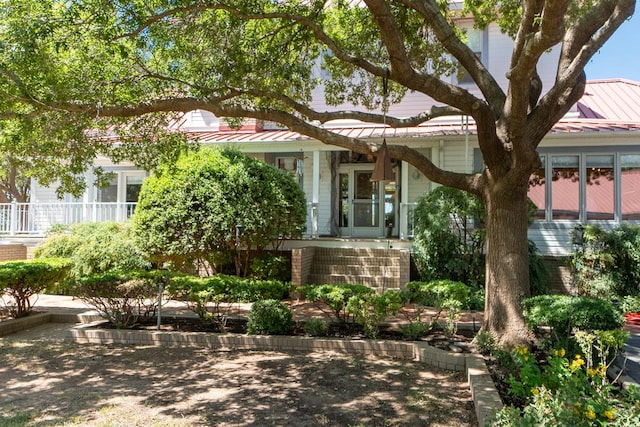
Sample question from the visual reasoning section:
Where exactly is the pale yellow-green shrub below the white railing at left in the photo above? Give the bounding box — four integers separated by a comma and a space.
35, 222, 151, 280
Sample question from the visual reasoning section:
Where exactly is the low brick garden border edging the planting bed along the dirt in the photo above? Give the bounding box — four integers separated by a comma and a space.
0, 313, 502, 426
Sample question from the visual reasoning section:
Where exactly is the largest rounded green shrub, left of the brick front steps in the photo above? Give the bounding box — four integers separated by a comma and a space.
134, 148, 306, 275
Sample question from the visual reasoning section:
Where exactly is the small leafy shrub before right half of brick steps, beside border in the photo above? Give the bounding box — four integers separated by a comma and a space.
346, 290, 403, 339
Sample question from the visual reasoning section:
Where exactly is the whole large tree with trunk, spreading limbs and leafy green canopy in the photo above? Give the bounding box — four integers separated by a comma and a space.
0, 0, 635, 344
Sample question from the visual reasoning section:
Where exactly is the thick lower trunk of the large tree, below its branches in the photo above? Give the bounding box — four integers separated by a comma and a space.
483, 179, 533, 347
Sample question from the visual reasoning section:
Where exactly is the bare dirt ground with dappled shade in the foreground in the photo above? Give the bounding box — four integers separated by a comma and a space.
0, 324, 477, 427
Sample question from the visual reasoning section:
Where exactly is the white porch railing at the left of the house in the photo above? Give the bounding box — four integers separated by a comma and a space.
0, 202, 136, 236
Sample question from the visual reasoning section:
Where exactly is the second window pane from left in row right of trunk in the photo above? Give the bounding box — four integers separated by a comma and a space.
551, 156, 580, 220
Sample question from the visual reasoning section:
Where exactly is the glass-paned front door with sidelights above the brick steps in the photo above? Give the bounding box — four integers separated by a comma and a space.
338, 164, 397, 237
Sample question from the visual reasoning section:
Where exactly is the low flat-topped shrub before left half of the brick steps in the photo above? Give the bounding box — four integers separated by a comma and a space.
298, 284, 375, 324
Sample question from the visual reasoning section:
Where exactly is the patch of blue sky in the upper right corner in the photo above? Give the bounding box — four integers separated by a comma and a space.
585, 2, 640, 82
